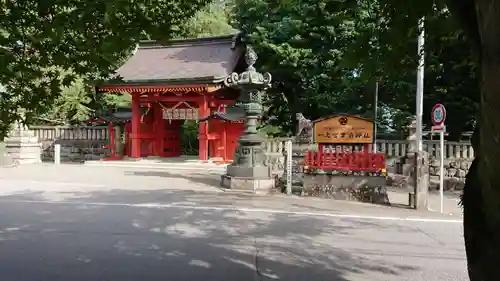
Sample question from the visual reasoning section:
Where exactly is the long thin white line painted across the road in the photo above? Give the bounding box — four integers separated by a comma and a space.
2, 200, 462, 223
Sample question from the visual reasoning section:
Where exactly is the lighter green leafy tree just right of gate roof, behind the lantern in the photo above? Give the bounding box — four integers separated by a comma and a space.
232, 0, 372, 136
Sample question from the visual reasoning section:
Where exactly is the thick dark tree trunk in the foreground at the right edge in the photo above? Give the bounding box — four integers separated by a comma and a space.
464, 0, 500, 281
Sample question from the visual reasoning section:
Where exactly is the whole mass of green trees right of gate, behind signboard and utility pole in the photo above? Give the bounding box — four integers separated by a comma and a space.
233, 0, 478, 137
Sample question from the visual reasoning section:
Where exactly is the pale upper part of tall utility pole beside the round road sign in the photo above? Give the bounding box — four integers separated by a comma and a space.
416, 17, 425, 153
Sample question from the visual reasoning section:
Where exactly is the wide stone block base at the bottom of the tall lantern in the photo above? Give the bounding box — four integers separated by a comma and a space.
221, 165, 275, 194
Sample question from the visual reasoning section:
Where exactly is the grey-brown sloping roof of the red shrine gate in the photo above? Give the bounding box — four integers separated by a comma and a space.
117, 35, 242, 83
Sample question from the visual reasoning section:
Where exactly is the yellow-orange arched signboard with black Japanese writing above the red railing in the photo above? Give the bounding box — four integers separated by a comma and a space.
314, 115, 374, 144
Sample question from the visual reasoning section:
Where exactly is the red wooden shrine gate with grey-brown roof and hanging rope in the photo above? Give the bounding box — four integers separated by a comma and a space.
97, 35, 246, 162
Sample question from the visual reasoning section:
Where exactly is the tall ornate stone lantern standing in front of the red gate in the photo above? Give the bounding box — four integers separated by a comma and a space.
221, 46, 274, 193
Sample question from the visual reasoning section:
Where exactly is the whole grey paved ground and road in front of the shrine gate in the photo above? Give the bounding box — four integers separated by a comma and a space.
0, 166, 467, 281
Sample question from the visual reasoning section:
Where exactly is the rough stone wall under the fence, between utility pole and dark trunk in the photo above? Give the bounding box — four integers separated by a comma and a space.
429, 157, 472, 191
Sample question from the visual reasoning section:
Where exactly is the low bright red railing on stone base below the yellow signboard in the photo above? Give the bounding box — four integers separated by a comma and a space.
304, 151, 386, 172
